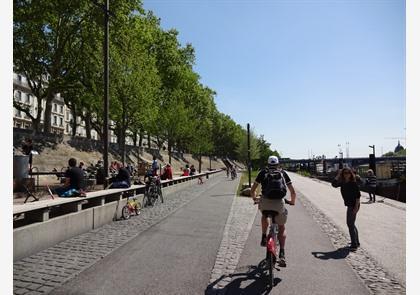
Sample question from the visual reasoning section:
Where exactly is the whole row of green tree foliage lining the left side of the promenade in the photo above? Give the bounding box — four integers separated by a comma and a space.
13, 0, 277, 162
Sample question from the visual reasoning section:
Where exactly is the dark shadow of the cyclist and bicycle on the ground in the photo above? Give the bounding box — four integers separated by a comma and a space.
204, 259, 281, 295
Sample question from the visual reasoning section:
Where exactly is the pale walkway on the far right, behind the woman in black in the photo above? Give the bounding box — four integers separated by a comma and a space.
290, 173, 406, 285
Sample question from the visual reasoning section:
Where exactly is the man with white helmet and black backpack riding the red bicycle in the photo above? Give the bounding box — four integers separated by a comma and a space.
251, 156, 296, 267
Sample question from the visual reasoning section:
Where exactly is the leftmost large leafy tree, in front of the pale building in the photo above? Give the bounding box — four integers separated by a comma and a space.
13, 0, 89, 133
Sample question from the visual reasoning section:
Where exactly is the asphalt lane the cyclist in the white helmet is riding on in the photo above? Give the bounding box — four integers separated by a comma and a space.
225, 195, 370, 295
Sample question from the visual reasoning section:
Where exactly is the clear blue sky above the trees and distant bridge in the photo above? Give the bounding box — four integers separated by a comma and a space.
144, 0, 406, 158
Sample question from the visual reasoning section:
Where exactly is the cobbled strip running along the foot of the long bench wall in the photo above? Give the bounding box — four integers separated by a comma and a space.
13, 175, 225, 294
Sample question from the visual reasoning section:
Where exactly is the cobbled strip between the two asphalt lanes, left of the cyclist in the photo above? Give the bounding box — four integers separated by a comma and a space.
206, 197, 258, 294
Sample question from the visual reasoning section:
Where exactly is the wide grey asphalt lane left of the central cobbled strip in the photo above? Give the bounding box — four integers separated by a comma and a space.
51, 177, 238, 294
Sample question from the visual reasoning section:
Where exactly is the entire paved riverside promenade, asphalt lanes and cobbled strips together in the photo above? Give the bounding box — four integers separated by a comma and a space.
13, 173, 405, 295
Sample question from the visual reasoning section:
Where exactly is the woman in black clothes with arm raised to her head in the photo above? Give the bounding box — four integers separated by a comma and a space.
332, 168, 360, 251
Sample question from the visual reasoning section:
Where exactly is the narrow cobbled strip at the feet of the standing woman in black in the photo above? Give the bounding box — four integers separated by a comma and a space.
297, 191, 406, 295
